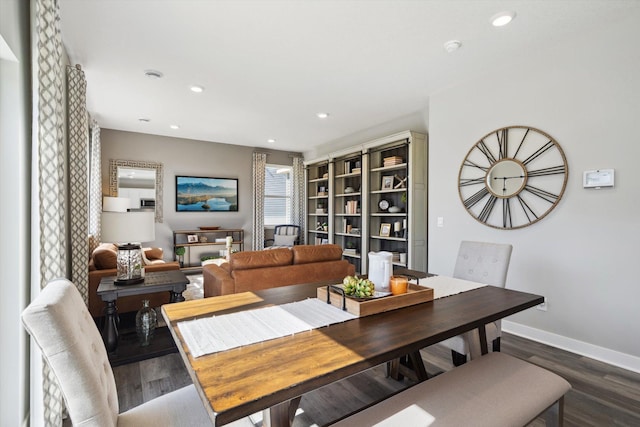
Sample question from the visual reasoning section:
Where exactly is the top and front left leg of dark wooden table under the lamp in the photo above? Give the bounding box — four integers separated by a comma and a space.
97, 270, 189, 353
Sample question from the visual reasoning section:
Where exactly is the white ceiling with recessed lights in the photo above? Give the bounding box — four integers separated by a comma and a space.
60, 0, 640, 152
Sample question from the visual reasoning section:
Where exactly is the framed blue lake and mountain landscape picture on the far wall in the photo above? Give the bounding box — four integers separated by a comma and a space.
176, 176, 238, 212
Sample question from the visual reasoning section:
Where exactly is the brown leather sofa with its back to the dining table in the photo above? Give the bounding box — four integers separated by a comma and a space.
202, 245, 355, 297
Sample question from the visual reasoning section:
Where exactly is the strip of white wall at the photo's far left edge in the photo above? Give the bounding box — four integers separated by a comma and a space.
0, 0, 31, 426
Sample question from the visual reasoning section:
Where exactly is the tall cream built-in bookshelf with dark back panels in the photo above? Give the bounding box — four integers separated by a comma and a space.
305, 131, 427, 274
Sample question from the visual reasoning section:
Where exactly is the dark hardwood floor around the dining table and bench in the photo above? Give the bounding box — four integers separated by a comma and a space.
114, 334, 640, 427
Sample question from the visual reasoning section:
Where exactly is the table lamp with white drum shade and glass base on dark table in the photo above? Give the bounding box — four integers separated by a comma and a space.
101, 211, 156, 286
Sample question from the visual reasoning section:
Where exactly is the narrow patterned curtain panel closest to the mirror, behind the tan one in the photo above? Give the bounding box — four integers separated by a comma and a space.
87, 120, 102, 252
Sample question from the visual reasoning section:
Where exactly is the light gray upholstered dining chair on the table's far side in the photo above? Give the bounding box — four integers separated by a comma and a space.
440, 241, 513, 366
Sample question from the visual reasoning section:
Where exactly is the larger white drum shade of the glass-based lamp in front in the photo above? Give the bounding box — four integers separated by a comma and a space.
101, 211, 156, 243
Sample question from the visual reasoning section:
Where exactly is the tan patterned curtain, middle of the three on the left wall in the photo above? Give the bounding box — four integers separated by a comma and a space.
67, 65, 91, 304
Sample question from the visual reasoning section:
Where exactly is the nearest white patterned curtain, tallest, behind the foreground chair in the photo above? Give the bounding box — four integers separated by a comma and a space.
33, 0, 67, 427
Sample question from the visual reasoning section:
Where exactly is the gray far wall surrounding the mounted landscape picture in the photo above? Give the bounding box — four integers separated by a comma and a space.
102, 129, 292, 260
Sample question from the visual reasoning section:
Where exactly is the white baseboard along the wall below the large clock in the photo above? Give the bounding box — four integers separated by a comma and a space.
502, 320, 640, 373
